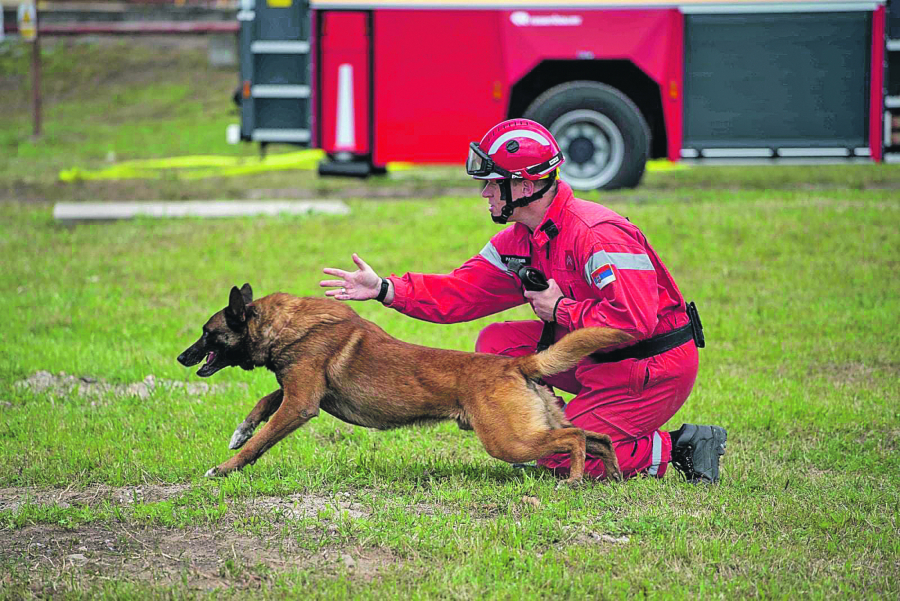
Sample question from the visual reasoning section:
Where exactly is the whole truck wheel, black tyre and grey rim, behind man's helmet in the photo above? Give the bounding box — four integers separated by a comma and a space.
524, 81, 650, 190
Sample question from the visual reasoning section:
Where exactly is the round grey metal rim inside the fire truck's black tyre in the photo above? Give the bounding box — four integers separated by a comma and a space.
549, 109, 625, 190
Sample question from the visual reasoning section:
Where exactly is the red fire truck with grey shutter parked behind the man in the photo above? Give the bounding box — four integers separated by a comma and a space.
238, 0, 900, 189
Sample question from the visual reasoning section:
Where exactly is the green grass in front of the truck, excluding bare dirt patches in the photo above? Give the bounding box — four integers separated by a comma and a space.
0, 191, 900, 597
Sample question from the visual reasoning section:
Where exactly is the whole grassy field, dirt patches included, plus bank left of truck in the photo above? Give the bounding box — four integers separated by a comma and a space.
0, 36, 900, 599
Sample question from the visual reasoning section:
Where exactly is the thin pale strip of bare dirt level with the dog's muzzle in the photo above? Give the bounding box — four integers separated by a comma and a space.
15, 371, 247, 399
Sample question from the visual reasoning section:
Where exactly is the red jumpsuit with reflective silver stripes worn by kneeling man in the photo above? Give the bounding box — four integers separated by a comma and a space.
390, 181, 698, 478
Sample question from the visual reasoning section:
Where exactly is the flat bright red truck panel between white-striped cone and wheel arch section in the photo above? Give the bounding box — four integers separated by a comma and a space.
373, 10, 508, 165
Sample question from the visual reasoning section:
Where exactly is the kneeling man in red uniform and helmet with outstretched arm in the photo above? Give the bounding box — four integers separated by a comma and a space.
321, 119, 726, 483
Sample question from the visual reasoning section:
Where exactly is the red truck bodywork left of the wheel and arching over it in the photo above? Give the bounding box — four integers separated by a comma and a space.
374, 9, 683, 165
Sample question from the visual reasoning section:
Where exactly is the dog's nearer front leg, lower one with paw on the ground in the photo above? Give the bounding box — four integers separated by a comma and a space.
206, 368, 325, 477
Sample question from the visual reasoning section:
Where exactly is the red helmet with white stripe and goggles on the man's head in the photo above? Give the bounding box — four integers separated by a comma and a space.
466, 119, 565, 180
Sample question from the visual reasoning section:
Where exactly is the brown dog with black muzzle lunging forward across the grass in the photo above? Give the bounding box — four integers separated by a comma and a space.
178, 284, 631, 482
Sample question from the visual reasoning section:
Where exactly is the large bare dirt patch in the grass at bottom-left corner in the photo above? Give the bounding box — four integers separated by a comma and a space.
0, 525, 401, 589
